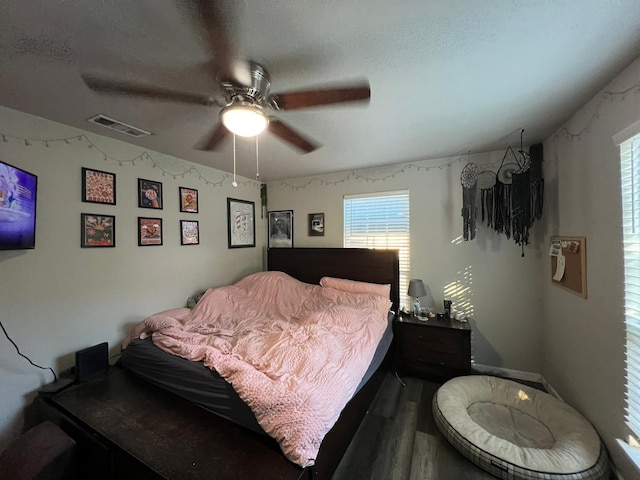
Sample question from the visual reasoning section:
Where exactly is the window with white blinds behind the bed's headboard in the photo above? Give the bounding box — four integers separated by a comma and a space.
344, 191, 411, 304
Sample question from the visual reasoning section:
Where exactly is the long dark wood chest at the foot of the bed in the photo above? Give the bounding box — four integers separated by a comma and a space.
38, 367, 303, 480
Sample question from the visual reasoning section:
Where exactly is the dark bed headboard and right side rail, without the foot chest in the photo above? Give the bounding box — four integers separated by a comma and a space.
267, 248, 400, 480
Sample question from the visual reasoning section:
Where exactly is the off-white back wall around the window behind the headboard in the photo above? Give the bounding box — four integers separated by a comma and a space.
268, 152, 545, 372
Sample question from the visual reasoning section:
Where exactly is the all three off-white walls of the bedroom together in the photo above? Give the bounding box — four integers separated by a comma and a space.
6, 52, 640, 480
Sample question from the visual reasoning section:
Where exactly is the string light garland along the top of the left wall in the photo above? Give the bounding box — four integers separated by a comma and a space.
0, 133, 260, 188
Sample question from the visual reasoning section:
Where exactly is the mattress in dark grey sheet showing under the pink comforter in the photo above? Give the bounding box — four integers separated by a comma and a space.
121, 312, 394, 435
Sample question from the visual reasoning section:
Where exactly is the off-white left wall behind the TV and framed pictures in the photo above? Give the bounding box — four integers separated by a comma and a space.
0, 107, 266, 451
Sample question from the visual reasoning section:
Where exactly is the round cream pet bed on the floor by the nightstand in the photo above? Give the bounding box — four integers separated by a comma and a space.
433, 375, 609, 480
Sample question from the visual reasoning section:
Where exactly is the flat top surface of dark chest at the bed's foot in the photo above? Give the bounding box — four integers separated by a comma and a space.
51, 367, 302, 480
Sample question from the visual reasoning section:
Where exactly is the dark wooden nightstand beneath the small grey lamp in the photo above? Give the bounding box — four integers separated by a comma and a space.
393, 315, 471, 380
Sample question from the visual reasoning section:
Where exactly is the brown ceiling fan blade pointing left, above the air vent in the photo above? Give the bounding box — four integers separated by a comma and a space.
82, 75, 217, 106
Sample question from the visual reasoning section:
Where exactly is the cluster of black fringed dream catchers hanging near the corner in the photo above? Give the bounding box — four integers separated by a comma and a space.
460, 130, 544, 257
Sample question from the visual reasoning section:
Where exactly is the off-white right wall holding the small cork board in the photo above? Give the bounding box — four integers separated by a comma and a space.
541, 55, 640, 479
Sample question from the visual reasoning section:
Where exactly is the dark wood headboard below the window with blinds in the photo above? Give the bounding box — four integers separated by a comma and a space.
267, 248, 400, 312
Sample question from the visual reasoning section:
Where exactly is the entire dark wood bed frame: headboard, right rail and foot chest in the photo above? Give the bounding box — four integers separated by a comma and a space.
38, 248, 399, 480
